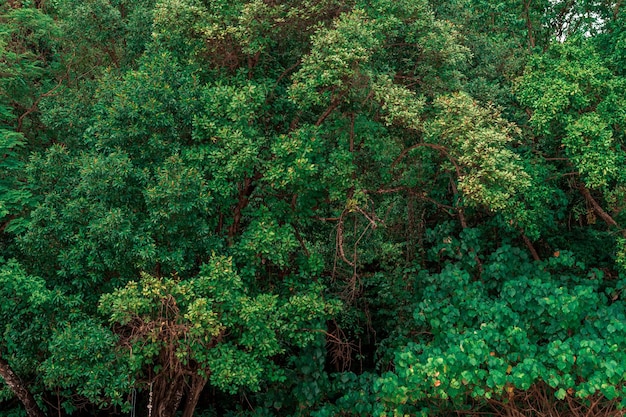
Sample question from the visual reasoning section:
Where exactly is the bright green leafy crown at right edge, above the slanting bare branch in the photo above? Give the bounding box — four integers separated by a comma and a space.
519, 39, 624, 189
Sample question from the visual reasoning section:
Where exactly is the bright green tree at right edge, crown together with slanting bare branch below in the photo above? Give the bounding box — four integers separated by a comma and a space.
516, 34, 625, 266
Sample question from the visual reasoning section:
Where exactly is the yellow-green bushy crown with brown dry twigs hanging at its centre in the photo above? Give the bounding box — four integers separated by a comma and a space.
99, 257, 335, 393
